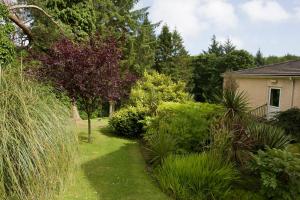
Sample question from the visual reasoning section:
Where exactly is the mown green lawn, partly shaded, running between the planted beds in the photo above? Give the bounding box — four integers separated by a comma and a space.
62, 119, 169, 200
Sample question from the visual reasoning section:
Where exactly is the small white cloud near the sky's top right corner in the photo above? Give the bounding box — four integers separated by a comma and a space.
241, 0, 291, 22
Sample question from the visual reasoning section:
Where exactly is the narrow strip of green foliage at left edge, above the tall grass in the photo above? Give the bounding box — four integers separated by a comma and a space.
0, 4, 15, 66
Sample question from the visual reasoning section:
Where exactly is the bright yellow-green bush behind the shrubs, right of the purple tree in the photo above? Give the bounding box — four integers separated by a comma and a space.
130, 72, 191, 114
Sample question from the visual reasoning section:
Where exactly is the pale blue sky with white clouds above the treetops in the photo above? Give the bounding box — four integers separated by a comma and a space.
137, 0, 300, 56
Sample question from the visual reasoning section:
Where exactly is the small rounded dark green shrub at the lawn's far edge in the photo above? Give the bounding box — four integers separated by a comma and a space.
109, 106, 147, 138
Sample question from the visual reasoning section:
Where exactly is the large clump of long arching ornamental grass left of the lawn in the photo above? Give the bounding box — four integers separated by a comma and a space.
0, 72, 77, 200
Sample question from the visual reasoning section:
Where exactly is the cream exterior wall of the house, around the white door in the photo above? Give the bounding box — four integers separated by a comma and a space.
235, 77, 300, 111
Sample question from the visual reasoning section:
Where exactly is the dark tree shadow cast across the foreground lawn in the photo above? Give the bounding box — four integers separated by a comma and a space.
81, 143, 162, 200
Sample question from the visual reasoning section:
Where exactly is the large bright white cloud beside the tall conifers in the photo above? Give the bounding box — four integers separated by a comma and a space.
150, 0, 238, 41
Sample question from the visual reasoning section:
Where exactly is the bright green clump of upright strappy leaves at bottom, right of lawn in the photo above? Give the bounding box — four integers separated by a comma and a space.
155, 153, 238, 200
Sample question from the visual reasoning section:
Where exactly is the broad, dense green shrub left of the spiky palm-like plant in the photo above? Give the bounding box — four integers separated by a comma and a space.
145, 102, 223, 153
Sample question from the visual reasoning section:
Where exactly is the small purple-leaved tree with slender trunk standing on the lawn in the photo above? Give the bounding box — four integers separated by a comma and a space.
38, 36, 135, 142
